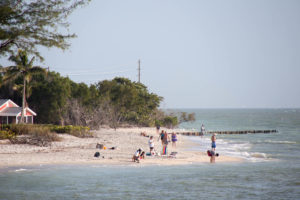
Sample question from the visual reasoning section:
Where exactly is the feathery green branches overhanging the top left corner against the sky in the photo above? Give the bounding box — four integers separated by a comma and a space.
0, 0, 90, 60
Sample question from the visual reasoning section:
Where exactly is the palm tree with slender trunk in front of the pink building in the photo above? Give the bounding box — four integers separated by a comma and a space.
2, 50, 46, 123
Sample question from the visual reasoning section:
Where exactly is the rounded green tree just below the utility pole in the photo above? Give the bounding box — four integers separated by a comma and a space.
97, 78, 162, 125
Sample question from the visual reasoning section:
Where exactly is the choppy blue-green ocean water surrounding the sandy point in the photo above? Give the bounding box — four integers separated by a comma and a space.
0, 109, 300, 200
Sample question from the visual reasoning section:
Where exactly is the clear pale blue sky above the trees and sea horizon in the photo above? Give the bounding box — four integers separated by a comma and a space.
0, 0, 300, 108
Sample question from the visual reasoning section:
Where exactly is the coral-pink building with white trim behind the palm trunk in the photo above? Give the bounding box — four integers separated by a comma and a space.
0, 99, 36, 124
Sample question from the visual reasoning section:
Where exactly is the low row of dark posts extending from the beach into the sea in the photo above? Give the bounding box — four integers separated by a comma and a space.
177, 130, 278, 136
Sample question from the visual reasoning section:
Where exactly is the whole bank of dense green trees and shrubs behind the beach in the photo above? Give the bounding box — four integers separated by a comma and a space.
0, 68, 178, 128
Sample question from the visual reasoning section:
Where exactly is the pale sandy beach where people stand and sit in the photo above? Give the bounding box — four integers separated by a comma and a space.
0, 128, 242, 168
